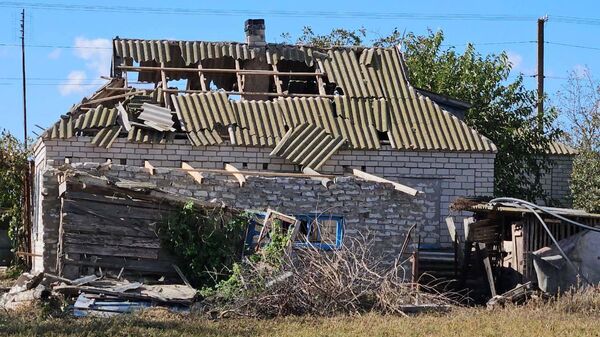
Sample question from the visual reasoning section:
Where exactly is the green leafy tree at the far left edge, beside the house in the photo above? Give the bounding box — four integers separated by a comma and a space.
0, 130, 28, 258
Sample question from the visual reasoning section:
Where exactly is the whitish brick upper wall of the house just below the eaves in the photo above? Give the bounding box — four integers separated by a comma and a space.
30, 137, 495, 270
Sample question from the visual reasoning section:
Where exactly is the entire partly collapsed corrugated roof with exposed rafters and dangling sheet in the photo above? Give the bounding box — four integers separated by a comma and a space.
43, 38, 496, 169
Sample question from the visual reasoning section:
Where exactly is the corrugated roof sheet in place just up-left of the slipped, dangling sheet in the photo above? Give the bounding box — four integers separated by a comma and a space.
231, 101, 286, 146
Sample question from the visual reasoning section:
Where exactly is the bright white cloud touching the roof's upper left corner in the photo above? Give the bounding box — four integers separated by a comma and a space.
75, 37, 112, 77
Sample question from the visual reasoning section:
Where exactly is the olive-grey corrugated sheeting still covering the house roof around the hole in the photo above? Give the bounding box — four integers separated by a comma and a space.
46, 39, 502, 158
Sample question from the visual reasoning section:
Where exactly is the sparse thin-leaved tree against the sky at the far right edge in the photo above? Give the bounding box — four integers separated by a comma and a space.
558, 68, 600, 212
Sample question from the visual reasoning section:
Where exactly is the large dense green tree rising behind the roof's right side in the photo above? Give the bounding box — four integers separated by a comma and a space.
288, 27, 560, 200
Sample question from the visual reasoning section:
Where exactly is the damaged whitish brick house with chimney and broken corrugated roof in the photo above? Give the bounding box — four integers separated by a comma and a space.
31, 20, 572, 280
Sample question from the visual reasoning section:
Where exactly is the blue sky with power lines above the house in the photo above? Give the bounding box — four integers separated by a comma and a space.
0, 0, 600, 139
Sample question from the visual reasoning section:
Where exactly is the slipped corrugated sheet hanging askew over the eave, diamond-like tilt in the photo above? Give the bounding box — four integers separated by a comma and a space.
271, 124, 345, 170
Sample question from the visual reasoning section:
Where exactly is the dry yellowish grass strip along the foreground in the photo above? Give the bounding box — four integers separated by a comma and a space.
0, 289, 600, 337
